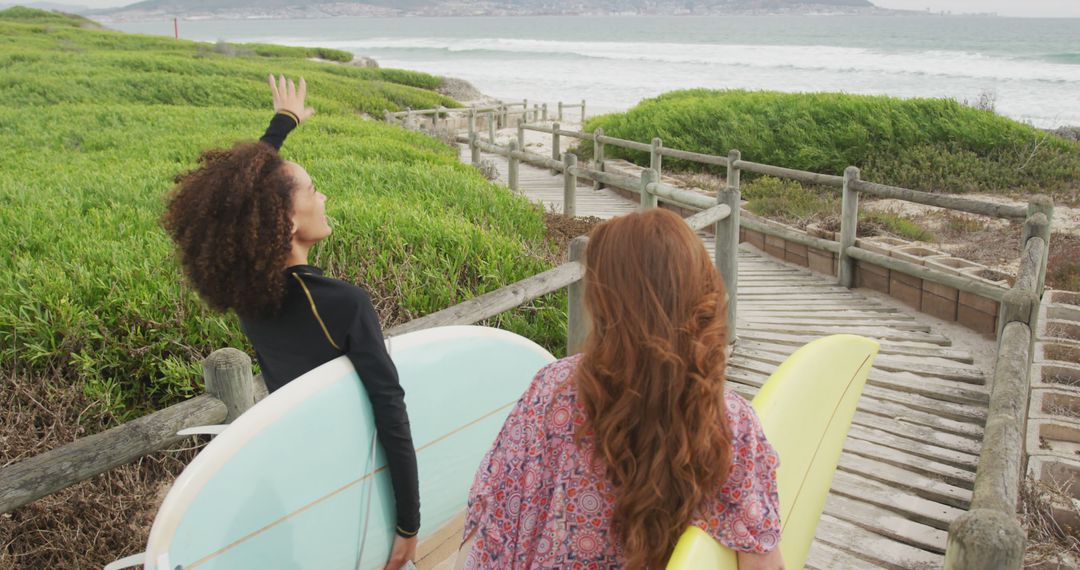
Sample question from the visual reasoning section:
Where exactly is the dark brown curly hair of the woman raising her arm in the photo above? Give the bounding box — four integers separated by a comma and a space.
162, 143, 295, 317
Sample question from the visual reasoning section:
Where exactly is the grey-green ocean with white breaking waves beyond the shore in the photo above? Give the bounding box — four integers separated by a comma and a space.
109, 16, 1080, 127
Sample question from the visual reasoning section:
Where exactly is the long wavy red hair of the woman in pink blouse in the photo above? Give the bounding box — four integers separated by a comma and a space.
575, 208, 731, 569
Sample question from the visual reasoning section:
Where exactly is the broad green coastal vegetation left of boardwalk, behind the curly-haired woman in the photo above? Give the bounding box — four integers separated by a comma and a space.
0, 9, 565, 421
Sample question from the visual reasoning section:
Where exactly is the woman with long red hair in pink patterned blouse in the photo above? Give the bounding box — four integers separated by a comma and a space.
458, 208, 783, 570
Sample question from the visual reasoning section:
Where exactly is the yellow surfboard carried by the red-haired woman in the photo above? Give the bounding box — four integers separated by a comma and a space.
667, 335, 878, 570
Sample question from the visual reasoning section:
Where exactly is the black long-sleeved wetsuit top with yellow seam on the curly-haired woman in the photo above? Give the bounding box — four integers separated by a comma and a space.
240, 114, 420, 537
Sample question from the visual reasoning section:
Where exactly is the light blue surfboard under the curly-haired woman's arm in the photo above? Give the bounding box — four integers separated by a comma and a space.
144, 326, 554, 570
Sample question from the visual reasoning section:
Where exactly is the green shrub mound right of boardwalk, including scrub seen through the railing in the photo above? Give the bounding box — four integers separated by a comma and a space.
582, 90, 1080, 290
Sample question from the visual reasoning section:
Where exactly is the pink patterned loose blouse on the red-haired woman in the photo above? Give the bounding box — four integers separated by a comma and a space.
464, 356, 780, 570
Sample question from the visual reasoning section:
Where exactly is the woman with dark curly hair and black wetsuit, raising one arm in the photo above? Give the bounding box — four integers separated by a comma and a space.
162, 76, 420, 570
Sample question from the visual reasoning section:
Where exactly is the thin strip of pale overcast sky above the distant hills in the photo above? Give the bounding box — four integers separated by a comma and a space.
16, 0, 1080, 17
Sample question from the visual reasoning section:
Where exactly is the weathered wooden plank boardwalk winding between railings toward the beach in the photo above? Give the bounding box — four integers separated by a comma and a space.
432, 139, 989, 570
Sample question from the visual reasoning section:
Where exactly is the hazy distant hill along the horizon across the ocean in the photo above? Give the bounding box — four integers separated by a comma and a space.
99, 0, 879, 17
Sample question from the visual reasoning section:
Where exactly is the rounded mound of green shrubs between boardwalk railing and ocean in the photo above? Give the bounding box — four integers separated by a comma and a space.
585, 90, 1080, 199
